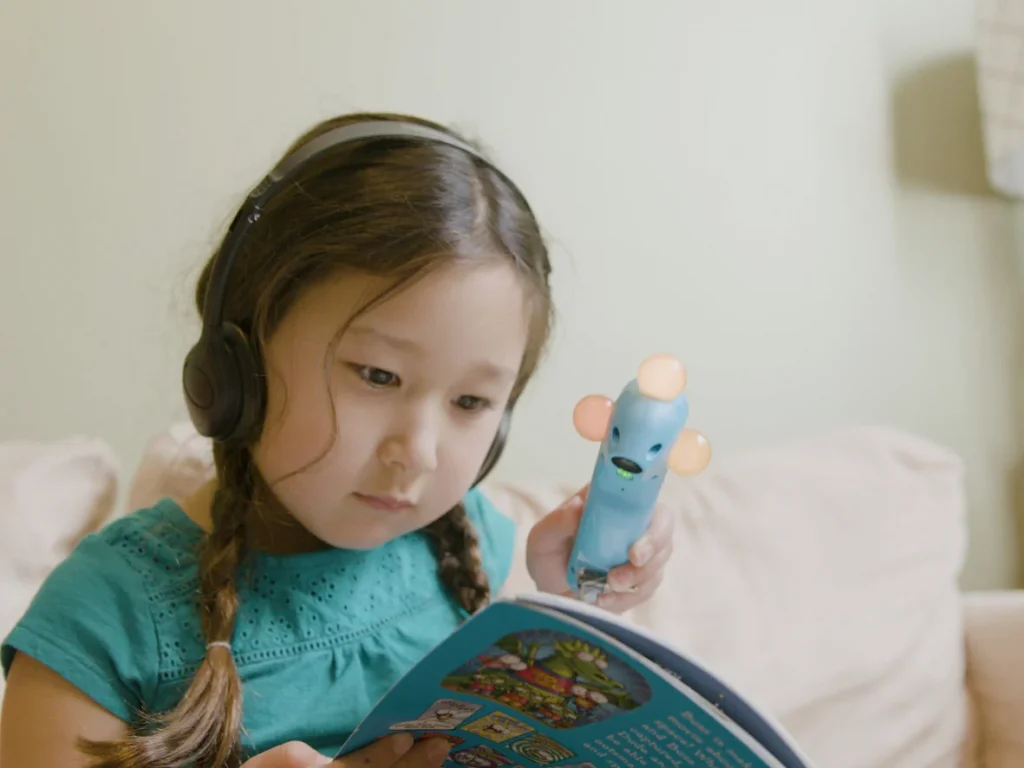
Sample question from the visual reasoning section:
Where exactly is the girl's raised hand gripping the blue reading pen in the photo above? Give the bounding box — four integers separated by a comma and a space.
526, 485, 675, 613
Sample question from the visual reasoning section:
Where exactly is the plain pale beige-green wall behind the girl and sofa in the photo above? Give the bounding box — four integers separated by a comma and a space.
0, 0, 1021, 586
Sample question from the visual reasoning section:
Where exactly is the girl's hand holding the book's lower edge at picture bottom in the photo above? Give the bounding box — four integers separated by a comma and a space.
242, 733, 452, 768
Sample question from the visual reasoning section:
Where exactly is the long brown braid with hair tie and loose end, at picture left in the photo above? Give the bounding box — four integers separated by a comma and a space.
81, 443, 254, 768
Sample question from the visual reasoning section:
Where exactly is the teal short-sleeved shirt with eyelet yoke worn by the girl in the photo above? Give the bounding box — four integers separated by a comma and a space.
0, 489, 515, 755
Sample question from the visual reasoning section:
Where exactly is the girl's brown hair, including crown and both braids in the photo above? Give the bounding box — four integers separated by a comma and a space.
82, 114, 552, 768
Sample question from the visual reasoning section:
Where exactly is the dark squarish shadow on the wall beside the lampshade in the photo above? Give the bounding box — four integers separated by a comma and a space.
891, 54, 999, 198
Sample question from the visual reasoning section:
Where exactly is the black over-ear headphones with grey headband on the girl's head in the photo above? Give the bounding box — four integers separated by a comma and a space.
182, 120, 521, 485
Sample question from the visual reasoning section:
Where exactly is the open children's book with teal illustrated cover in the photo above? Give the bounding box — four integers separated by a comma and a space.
340, 595, 811, 768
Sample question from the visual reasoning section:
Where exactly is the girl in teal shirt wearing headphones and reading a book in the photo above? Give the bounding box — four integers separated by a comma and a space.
0, 115, 672, 768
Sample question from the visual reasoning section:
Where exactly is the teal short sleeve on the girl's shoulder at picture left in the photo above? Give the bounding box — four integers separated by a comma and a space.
0, 534, 158, 722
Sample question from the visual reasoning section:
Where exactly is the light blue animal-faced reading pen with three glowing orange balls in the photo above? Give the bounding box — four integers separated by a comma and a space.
566, 354, 711, 603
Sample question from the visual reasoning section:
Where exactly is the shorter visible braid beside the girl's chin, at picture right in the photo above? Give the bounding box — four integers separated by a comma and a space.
427, 503, 490, 613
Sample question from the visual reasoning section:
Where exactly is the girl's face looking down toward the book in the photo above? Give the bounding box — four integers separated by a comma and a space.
253, 260, 528, 549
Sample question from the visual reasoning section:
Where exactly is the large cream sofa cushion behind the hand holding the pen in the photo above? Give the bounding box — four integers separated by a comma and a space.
489, 428, 967, 768
